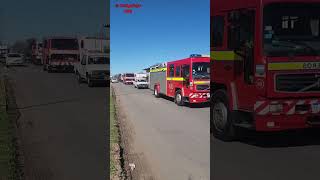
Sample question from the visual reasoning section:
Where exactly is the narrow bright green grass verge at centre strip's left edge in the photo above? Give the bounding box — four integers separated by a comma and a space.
110, 94, 119, 176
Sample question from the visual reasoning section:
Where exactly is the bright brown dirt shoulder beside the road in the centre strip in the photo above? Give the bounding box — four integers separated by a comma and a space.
112, 85, 156, 180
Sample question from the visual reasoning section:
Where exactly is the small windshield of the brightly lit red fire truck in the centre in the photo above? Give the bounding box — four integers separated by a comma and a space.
192, 62, 210, 79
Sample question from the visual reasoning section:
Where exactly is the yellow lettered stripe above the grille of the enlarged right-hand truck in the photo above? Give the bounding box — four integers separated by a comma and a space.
268, 62, 320, 71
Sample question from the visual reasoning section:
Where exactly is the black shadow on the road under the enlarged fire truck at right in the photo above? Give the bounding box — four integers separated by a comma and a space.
239, 129, 320, 148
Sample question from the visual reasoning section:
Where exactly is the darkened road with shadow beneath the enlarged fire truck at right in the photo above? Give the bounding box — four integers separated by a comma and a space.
211, 118, 320, 180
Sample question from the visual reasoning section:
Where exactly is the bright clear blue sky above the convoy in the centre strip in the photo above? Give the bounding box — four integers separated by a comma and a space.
110, 0, 210, 74
